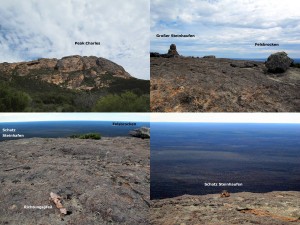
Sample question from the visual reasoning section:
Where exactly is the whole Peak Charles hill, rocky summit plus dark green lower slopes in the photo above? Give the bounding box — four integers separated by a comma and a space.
0, 55, 150, 112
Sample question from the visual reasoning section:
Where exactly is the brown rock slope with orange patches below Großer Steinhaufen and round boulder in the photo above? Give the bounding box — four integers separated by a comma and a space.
150, 57, 300, 112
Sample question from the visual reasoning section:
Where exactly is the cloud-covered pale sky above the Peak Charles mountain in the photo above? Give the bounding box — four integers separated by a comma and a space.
0, 0, 150, 79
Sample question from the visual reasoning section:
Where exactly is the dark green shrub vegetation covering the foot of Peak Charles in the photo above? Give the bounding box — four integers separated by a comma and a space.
0, 69, 150, 112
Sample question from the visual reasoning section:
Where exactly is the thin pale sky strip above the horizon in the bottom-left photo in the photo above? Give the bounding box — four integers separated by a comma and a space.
0, 113, 150, 122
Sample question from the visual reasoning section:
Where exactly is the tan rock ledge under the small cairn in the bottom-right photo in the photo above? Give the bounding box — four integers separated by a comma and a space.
150, 191, 300, 225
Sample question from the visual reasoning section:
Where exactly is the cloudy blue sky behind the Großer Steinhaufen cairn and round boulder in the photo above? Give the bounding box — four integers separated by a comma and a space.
150, 0, 300, 58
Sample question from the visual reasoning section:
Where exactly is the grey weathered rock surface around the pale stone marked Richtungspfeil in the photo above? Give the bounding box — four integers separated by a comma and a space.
0, 137, 150, 225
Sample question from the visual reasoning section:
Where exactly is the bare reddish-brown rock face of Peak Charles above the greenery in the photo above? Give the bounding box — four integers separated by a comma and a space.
0, 55, 132, 90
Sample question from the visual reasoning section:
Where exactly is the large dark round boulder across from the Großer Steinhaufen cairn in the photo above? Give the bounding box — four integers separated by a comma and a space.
265, 52, 293, 73
